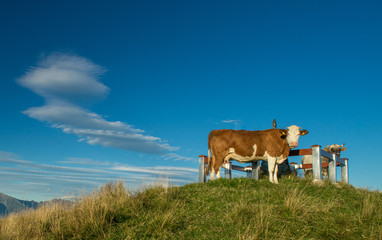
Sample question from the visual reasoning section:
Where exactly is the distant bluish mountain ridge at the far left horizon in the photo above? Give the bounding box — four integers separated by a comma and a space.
0, 193, 70, 217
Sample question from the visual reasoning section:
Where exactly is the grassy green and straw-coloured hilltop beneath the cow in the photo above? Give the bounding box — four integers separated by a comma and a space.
0, 177, 382, 239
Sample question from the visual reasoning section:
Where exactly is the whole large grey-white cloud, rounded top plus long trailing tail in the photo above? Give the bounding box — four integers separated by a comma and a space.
17, 53, 178, 154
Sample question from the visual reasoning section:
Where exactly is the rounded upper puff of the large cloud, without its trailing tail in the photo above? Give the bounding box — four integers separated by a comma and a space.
18, 53, 109, 101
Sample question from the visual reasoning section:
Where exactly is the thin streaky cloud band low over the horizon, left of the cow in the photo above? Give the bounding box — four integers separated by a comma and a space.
0, 152, 198, 200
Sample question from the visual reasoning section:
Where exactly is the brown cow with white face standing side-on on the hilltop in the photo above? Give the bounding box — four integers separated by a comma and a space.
206, 125, 308, 183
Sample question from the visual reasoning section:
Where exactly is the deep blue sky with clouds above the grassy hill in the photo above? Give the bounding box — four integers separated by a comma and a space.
0, 1, 382, 201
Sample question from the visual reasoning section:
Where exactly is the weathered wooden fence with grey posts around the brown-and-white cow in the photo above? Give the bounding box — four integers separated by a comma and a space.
199, 145, 349, 184
